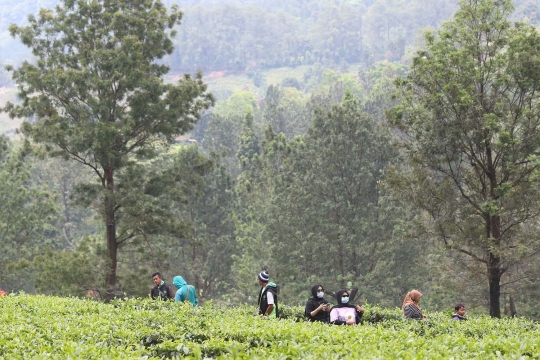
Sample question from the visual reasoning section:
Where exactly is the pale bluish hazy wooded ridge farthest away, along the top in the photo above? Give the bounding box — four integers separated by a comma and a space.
0, 0, 540, 76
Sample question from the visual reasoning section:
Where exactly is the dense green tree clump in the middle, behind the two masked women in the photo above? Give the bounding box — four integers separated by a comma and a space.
234, 91, 410, 305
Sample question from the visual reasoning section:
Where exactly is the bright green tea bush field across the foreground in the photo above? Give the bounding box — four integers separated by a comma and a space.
0, 295, 540, 359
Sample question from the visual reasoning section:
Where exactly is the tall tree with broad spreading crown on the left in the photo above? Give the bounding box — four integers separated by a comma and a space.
3, 0, 213, 297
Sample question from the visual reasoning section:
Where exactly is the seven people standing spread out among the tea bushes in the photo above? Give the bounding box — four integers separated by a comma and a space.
150, 270, 467, 325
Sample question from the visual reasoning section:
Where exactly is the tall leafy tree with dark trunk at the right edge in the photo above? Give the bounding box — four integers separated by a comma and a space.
390, 0, 540, 316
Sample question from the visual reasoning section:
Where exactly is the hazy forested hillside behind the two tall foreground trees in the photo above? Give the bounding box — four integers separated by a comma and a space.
0, 0, 540, 318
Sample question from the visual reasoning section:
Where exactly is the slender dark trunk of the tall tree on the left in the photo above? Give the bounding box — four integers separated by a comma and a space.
105, 168, 118, 300
